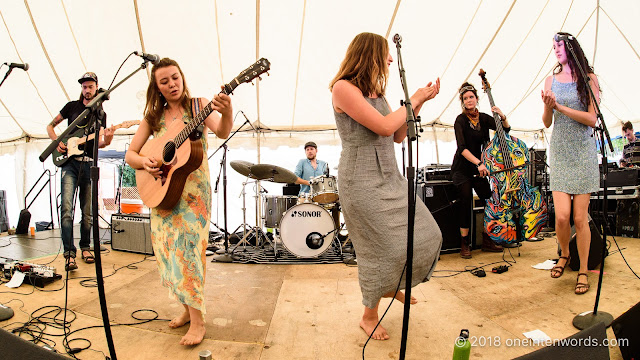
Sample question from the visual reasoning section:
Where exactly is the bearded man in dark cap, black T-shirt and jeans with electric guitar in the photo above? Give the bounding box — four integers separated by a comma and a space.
47, 72, 114, 271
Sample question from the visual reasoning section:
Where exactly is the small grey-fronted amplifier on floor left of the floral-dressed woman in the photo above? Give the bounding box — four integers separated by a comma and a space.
111, 214, 153, 255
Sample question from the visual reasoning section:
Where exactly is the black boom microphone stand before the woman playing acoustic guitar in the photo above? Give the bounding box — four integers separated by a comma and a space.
39, 60, 148, 360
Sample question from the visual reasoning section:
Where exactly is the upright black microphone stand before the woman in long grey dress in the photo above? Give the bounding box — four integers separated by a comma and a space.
394, 36, 417, 360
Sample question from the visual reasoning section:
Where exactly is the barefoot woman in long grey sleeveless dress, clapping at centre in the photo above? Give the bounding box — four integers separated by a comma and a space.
330, 33, 442, 340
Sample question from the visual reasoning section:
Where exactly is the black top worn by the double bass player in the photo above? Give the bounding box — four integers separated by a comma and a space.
451, 112, 511, 184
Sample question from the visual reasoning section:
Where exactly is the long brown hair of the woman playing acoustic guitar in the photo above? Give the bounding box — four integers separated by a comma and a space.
144, 58, 191, 132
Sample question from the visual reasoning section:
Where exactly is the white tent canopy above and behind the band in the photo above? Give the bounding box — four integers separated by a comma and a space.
0, 0, 640, 146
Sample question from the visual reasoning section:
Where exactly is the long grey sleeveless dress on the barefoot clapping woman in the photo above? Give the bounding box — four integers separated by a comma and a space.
334, 98, 442, 308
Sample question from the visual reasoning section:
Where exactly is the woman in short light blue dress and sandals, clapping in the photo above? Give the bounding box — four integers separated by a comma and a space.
541, 33, 600, 294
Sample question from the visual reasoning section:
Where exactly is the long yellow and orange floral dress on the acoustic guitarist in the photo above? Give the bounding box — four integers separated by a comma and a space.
150, 105, 211, 315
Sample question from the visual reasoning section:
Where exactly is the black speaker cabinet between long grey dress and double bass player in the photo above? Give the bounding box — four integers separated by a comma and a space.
416, 180, 462, 252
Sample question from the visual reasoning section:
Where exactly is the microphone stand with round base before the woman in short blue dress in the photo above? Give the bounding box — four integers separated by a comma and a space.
564, 40, 613, 330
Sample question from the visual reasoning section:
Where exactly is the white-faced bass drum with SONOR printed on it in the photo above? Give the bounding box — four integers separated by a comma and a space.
280, 204, 336, 258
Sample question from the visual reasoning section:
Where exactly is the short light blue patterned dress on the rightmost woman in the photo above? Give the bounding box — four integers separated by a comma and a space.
549, 76, 600, 195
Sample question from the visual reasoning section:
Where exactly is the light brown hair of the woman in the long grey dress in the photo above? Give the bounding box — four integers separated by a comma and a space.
329, 32, 389, 97
